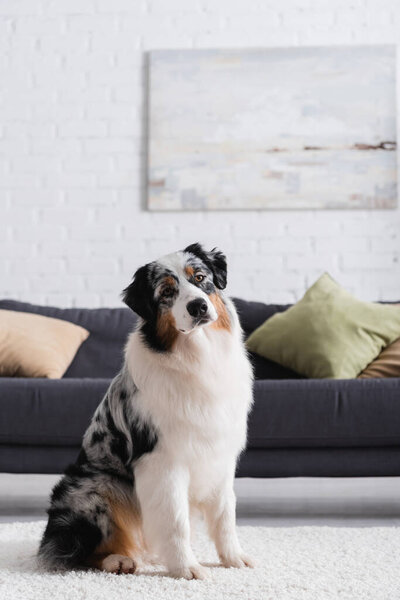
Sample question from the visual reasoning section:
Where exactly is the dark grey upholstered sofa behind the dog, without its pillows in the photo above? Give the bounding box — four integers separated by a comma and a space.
0, 298, 400, 477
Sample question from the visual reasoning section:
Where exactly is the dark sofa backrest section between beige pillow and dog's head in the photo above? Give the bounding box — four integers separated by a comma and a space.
0, 300, 136, 378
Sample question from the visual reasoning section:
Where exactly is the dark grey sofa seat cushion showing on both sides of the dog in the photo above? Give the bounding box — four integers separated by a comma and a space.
0, 378, 400, 451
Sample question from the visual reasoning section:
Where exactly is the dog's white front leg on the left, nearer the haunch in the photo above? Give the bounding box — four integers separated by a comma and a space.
135, 453, 207, 579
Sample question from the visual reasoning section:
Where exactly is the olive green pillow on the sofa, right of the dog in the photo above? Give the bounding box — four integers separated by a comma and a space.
247, 273, 400, 379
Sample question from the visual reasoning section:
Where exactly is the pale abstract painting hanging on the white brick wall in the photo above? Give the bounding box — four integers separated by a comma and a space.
148, 46, 397, 210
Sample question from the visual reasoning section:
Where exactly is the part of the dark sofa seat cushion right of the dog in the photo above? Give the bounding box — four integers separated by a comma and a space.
248, 378, 400, 448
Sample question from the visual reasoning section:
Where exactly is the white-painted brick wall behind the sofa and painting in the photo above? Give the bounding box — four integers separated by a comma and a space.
0, 0, 400, 306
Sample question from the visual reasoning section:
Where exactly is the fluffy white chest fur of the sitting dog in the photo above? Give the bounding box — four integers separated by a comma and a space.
126, 308, 252, 501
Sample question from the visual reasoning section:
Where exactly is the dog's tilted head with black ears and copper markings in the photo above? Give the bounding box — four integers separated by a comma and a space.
123, 244, 228, 350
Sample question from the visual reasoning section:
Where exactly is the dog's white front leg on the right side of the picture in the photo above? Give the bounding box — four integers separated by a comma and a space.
203, 481, 254, 568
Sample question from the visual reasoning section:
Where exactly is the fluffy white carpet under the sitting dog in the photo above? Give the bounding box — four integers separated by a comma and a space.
0, 522, 400, 600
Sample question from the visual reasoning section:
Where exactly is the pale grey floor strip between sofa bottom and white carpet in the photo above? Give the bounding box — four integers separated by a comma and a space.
0, 474, 400, 527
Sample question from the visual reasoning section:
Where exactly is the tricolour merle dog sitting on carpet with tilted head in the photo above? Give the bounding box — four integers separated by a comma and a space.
39, 243, 253, 579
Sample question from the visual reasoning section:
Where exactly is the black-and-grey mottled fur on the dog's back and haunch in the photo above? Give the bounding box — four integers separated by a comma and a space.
39, 368, 157, 568
